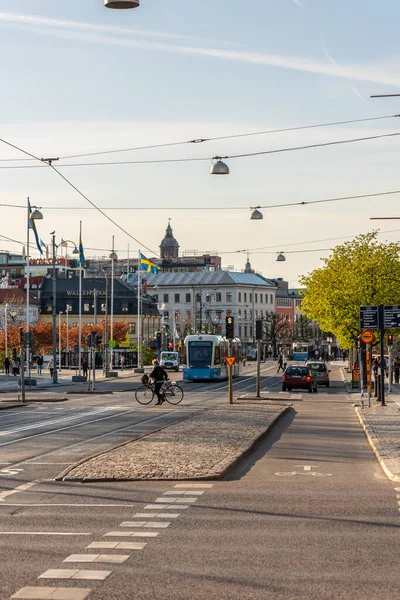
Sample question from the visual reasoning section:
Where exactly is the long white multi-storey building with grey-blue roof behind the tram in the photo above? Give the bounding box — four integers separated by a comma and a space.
147, 271, 277, 345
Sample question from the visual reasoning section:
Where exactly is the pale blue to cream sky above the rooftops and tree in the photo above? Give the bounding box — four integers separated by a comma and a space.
0, 0, 400, 287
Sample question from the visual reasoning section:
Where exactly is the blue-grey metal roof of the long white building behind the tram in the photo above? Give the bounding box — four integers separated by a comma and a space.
141, 271, 276, 288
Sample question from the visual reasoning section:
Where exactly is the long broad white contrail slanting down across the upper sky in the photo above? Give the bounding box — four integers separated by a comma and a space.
0, 12, 400, 86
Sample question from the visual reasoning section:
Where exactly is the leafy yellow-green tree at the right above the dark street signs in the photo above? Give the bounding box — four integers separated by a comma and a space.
301, 231, 400, 349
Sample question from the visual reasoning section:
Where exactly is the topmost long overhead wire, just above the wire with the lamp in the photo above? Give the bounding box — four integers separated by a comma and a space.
0, 115, 400, 162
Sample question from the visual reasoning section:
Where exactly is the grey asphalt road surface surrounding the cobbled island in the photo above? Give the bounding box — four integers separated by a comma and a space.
0, 363, 400, 600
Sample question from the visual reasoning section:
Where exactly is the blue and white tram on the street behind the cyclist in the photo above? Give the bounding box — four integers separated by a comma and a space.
183, 334, 242, 381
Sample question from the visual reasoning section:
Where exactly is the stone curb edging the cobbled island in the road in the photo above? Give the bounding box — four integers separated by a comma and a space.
54, 406, 292, 483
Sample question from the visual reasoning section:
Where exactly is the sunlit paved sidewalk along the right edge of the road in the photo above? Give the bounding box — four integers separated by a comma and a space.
342, 369, 400, 481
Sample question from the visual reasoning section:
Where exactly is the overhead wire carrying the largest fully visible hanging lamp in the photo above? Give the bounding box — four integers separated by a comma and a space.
0, 132, 400, 170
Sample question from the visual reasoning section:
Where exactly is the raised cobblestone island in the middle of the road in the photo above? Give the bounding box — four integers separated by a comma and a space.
58, 404, 288, 481
